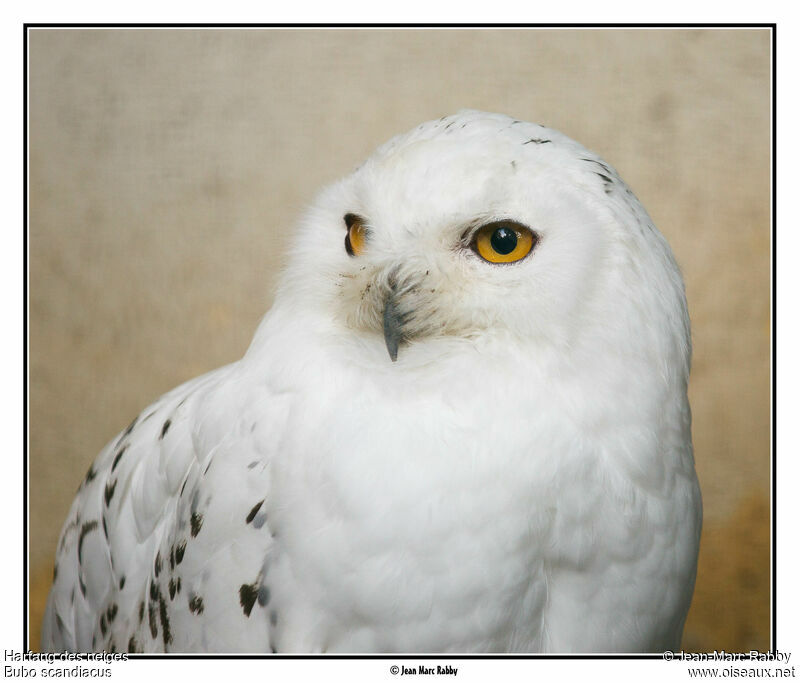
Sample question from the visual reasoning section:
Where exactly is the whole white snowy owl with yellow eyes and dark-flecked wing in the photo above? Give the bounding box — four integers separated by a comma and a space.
42, 111, 701, 653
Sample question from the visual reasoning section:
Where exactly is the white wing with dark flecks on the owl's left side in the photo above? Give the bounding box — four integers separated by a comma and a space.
42, 364, 282, 652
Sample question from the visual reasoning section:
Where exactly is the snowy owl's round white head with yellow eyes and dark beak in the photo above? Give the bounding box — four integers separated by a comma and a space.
277, 111, 688, 382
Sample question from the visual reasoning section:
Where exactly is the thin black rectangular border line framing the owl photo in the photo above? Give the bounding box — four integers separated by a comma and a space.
22, 23, 778, 660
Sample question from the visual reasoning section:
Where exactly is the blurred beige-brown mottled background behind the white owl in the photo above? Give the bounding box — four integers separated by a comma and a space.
29, 29, 770, 650
